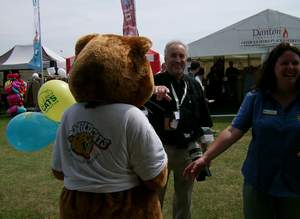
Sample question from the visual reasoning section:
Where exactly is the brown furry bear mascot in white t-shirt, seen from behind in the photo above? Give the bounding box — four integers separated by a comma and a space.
52, 34, 167, 219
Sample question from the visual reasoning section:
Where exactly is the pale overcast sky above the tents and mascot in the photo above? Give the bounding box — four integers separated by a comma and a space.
0, 0, 300, 57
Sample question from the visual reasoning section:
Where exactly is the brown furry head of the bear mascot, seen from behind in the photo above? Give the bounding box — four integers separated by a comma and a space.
69, 34, 154, 106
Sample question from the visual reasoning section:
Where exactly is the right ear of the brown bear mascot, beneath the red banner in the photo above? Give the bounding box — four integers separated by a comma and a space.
128, 36, 152, 58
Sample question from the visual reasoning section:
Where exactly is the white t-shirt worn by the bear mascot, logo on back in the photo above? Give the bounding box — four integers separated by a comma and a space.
52, 103, 167, 193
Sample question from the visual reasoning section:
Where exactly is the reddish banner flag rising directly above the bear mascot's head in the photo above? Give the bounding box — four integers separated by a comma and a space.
121, 0, 139, 36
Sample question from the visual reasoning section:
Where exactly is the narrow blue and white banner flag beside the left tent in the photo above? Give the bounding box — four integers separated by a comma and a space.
31, 0, 43, 72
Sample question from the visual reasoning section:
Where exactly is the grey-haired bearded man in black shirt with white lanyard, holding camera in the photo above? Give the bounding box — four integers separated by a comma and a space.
146, 41, 212, 219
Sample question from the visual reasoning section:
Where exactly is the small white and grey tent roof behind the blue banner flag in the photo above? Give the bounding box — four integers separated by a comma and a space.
0, 45, 66, 70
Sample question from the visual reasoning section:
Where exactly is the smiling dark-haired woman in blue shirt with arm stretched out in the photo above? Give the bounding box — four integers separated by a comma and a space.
184, 43, 300, 219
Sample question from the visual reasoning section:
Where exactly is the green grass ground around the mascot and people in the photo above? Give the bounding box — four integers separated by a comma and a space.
0, 117, 249, 219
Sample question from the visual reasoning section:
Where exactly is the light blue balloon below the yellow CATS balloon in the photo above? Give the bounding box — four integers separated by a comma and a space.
6, 112, 58, 152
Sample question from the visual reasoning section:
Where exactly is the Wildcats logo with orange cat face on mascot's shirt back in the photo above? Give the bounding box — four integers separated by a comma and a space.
68, 121, 111, 159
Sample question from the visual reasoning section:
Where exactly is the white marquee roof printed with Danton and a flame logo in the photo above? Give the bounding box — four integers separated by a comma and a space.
188, 9, 300, 57
